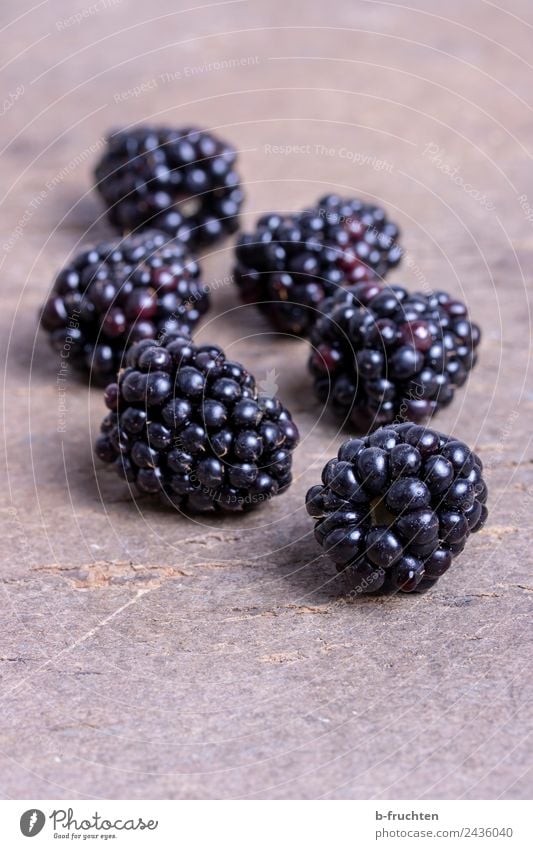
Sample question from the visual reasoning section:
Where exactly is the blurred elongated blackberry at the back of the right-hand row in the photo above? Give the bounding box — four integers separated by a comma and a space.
235, 195, 401, 336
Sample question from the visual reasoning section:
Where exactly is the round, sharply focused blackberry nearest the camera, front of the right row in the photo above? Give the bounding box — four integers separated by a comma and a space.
306, 422, 487, 593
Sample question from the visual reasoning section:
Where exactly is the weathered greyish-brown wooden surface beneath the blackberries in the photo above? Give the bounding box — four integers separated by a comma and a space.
0, 0, 533, 798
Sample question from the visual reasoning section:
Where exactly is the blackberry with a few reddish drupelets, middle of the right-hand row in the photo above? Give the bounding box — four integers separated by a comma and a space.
309, 283, 481, 432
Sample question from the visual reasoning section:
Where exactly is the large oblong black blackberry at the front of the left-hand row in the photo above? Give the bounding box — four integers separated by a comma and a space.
96, 334, 298, 512
